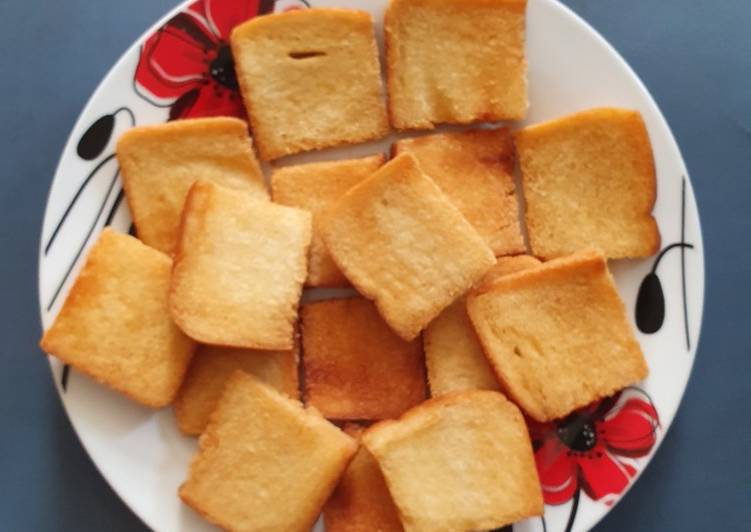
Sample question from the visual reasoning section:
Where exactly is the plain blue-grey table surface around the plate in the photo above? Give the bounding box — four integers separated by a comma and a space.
0, 0, 751, 532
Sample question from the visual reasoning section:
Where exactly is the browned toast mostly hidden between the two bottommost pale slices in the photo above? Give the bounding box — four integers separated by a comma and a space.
323, 423, 404, 532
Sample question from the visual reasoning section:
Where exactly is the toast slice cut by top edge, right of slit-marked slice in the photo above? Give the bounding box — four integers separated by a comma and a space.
384, 0, 528, 129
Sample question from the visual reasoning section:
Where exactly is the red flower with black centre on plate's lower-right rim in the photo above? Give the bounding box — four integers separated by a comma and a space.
529, 388, 660, 505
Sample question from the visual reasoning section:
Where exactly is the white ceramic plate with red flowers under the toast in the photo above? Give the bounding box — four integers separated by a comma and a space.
39, 0, 704, 532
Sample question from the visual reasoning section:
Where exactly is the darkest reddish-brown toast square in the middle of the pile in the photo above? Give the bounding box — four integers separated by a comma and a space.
301, 298, 425, 420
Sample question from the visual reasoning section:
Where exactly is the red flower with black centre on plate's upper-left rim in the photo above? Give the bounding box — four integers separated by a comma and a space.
134, 0, 275, 120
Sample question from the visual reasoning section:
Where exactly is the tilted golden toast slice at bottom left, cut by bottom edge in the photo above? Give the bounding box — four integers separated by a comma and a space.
180, 371, 357, 532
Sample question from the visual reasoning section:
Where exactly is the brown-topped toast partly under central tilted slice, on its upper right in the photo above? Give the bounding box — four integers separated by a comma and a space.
393, 128, 525, 256
